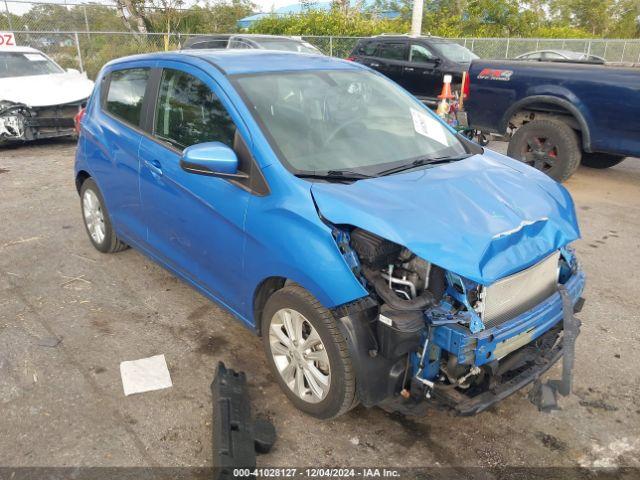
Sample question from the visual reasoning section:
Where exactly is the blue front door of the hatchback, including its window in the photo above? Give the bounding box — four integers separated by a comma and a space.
140, 64, 251, 311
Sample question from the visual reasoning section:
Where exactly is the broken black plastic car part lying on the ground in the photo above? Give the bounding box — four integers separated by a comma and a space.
211, 362, 276, 479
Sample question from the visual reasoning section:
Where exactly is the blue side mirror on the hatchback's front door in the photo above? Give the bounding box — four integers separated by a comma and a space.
180, 142, 248, 178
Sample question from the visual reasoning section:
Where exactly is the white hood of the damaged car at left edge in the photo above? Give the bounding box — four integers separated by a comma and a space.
0, 72, 93, 107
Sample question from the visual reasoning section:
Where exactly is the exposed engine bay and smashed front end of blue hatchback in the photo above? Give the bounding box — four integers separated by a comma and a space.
334, 228, 583, 414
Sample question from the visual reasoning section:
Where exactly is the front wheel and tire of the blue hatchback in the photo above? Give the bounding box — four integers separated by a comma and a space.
262, 284, 358, 419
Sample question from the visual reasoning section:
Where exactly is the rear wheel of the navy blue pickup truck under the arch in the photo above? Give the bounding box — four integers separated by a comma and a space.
507, 120, 582, 182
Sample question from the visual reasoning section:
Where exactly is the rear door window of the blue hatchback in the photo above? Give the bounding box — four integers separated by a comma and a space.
105, 68, 149, 126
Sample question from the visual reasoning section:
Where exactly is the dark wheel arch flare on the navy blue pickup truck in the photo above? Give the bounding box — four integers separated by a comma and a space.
499, 95, 591, 152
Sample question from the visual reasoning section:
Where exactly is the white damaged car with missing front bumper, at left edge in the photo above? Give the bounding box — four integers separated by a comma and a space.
0, 47, 93, 145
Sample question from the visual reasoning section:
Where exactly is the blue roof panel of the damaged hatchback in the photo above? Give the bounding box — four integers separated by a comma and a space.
109, 49, 365, 75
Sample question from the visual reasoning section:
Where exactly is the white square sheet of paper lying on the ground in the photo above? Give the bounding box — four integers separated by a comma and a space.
120, 355, 173, 395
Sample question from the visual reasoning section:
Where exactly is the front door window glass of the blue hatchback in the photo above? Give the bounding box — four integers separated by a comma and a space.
154, 69, 236, 150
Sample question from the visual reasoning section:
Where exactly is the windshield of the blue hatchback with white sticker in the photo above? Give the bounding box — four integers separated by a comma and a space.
236, 70, 466, 175
